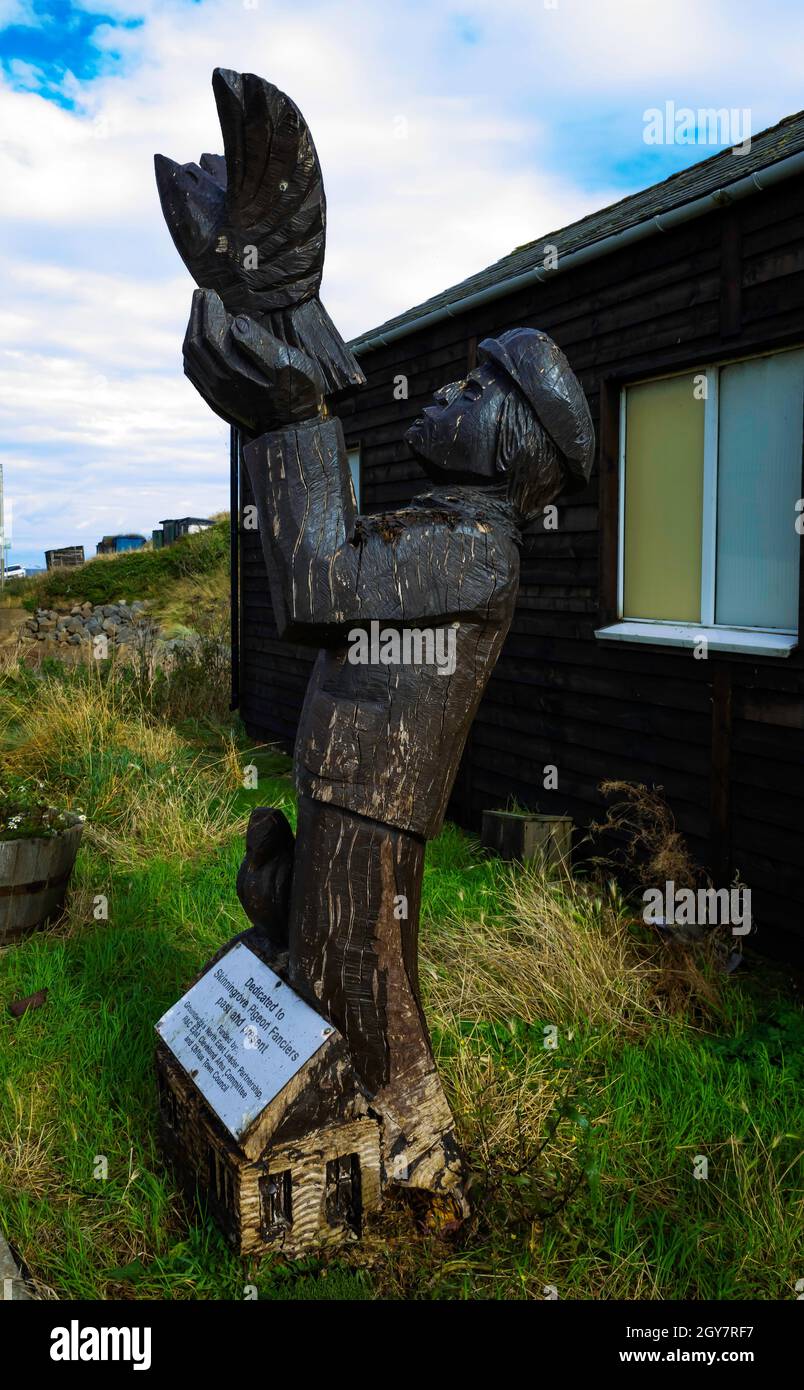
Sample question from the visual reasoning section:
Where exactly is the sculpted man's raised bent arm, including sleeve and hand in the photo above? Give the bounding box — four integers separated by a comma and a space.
184, 291, 515, 646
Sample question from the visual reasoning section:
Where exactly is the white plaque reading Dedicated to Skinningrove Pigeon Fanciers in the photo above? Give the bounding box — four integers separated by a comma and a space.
156, 941, 335, 1138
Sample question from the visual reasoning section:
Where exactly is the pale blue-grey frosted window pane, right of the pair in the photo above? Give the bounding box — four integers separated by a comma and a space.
715, 352, 804, 630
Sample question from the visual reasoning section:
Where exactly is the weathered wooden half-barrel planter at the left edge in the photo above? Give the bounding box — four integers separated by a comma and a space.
0, 815, 83, 945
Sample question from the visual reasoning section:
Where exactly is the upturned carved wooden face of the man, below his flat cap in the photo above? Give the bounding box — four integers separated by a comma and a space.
405, 363, 513, 484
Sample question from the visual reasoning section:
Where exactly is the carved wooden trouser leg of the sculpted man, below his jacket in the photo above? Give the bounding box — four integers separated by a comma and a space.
289, 796, 462, 1190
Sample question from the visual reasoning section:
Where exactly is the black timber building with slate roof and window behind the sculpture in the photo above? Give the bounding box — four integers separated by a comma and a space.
239, 114, 804, 959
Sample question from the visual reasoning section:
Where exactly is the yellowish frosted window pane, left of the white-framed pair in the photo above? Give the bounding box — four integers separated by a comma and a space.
623, 375, 704, 623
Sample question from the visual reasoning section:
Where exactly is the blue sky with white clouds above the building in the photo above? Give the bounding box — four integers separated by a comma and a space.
0, 0, 804, 564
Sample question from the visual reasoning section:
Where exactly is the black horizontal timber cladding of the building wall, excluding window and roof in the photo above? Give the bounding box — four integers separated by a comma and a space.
241, 178, 804, 958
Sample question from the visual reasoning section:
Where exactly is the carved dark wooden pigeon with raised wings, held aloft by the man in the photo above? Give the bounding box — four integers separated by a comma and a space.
154, 68, 366, 393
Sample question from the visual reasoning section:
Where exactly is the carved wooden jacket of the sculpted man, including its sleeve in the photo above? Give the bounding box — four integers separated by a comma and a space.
243, 418, 519, 838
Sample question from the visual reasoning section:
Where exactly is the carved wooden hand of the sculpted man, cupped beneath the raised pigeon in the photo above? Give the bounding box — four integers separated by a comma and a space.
184, 289, 324, 435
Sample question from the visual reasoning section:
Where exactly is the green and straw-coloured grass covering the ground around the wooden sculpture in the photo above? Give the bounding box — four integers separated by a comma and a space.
0, 650, 804, 1301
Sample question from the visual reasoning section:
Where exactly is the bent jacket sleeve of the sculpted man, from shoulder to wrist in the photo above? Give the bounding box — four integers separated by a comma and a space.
245, 420, 516, 646
